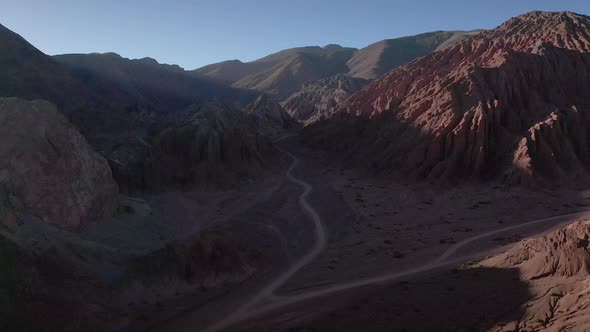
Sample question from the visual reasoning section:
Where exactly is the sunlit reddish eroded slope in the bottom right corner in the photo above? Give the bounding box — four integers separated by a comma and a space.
481, 221, 590, 331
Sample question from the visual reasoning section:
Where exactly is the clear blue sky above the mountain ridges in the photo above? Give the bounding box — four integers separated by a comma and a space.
0, 0, 590, 69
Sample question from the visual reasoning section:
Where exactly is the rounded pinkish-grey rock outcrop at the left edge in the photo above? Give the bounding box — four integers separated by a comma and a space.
0, 98, 118, 229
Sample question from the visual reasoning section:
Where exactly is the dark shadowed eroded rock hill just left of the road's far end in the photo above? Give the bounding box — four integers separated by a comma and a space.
109, 102, 280, 193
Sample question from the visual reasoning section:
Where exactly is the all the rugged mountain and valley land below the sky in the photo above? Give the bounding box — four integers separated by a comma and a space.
5, 7, 590, 332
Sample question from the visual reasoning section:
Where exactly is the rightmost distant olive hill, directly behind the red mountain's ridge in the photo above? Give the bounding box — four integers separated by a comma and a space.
348, 30, 482, 79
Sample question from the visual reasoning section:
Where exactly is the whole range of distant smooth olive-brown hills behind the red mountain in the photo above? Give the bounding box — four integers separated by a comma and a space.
194, 31, 478, 98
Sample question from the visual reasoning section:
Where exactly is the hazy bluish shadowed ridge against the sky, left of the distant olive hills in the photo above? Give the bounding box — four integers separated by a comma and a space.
53, 53, 250, 112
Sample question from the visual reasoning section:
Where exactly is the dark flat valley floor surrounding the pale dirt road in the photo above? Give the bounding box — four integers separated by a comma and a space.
140, 139, 590, 331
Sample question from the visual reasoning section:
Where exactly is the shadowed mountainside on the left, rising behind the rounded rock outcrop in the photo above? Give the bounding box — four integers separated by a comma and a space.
0, 21, 287, 197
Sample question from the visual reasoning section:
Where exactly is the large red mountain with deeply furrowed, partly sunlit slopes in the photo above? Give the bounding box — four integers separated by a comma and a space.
307, 12, 590, 185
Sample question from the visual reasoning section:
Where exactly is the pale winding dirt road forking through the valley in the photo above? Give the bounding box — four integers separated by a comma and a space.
203, 140, 590, 332
